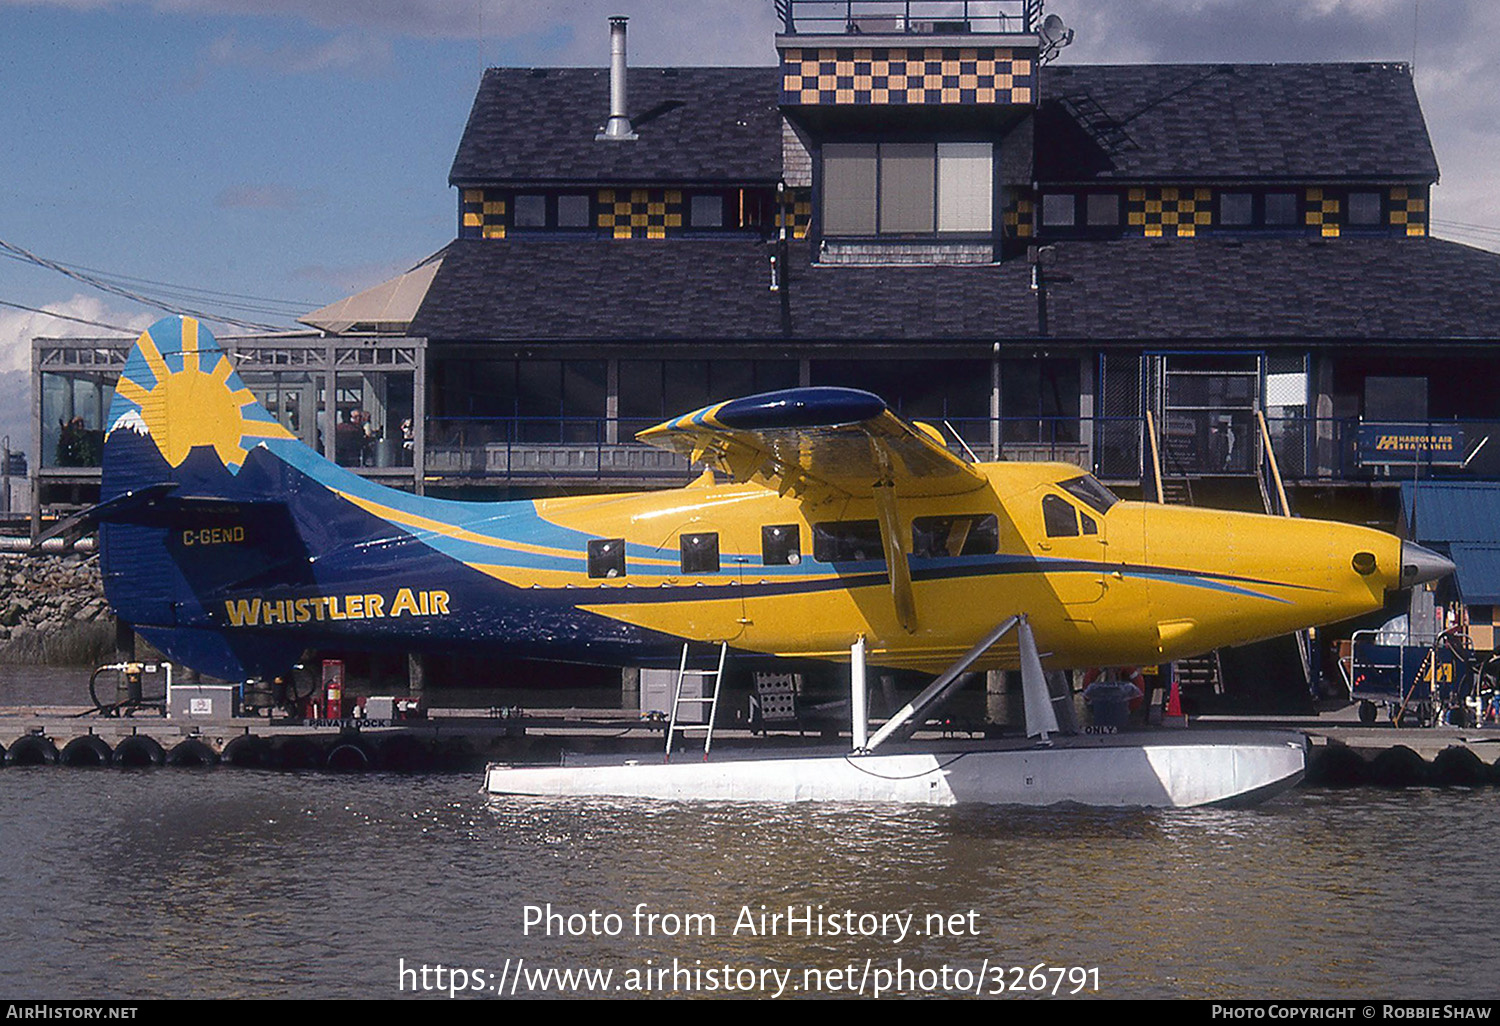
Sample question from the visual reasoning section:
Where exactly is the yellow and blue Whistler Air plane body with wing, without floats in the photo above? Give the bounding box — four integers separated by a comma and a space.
92, 317, 1451, 681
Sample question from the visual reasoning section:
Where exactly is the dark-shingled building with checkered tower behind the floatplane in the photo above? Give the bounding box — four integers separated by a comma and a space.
396, 0, 1500, 519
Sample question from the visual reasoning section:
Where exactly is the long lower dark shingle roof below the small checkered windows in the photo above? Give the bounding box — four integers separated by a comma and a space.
411, 237, 1500, 345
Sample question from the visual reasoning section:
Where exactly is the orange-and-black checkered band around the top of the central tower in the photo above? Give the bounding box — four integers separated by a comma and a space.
782, 47, 1037, 107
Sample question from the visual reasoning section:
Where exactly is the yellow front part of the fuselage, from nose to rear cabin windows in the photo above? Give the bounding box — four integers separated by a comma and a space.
480, 464, 1401, 671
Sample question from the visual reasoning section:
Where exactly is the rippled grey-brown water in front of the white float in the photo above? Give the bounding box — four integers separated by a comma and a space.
0, 768, 1500, 999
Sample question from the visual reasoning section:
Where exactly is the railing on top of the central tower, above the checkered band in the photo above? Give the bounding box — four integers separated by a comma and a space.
776, 0, 1043, 36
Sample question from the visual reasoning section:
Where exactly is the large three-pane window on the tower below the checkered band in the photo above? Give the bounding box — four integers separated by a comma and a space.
822, 143, 995, 237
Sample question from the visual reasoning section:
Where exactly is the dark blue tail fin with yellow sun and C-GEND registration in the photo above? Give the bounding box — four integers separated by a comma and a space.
101, 317, 331, 680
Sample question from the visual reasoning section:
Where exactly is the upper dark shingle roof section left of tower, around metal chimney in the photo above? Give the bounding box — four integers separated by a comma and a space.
449, 68, 782, 186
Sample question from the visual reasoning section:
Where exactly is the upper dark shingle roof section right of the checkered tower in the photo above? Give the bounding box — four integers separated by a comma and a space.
1037, 65, 1437, 183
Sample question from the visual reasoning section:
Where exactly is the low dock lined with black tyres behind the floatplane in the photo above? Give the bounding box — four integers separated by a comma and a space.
0, 707, 1500, 788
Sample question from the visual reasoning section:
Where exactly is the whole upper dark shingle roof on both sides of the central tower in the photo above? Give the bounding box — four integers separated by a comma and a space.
449, 63, 1437, 185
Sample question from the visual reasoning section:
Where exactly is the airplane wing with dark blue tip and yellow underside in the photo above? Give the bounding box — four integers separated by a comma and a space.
636, 389, 986, 503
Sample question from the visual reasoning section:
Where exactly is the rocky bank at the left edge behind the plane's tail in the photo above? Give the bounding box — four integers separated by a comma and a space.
0, 552, 114, 666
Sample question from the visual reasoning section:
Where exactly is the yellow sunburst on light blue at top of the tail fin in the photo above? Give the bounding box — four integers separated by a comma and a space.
110, 317, 293, 471
